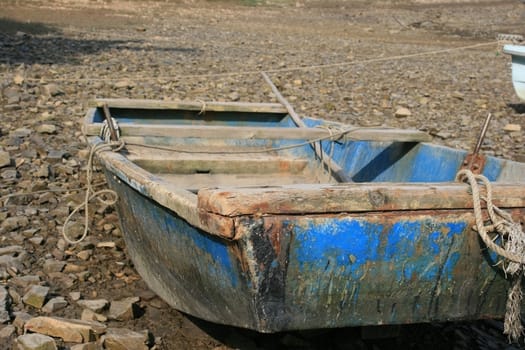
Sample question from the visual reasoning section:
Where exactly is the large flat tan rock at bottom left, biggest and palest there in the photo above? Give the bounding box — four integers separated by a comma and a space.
24, 316, 107, 343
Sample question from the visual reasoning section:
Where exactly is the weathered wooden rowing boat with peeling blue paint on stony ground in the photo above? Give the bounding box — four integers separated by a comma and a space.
84, 100, 525, 332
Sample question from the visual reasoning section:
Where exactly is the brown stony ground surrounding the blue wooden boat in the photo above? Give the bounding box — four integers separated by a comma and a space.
0, 0, 525, 350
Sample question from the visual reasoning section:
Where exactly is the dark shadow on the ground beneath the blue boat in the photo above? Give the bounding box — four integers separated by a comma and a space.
184, 315, 521, 350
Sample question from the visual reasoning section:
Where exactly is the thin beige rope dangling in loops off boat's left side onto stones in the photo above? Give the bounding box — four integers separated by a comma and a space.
62, 141, 124, 244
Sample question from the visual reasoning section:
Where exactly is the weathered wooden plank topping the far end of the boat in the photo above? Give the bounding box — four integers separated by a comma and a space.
90, 98, 287, 114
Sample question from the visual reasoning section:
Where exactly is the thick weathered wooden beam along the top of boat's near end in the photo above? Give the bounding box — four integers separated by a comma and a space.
198, 183, 525, 216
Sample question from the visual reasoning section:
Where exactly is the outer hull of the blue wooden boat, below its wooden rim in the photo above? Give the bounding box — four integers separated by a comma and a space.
106, 171, 512, 332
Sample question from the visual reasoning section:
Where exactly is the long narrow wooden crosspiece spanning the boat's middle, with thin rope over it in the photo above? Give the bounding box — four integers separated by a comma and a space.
85, 123, 431, 142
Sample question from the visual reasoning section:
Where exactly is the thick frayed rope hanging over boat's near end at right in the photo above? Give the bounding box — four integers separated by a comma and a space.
456, 170, 525, 342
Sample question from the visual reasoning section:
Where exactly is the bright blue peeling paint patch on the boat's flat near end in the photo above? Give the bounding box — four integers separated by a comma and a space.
291, 218, 467, 288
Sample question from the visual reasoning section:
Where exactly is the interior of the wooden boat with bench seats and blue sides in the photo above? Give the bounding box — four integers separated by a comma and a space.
85, 99, 525, 193
